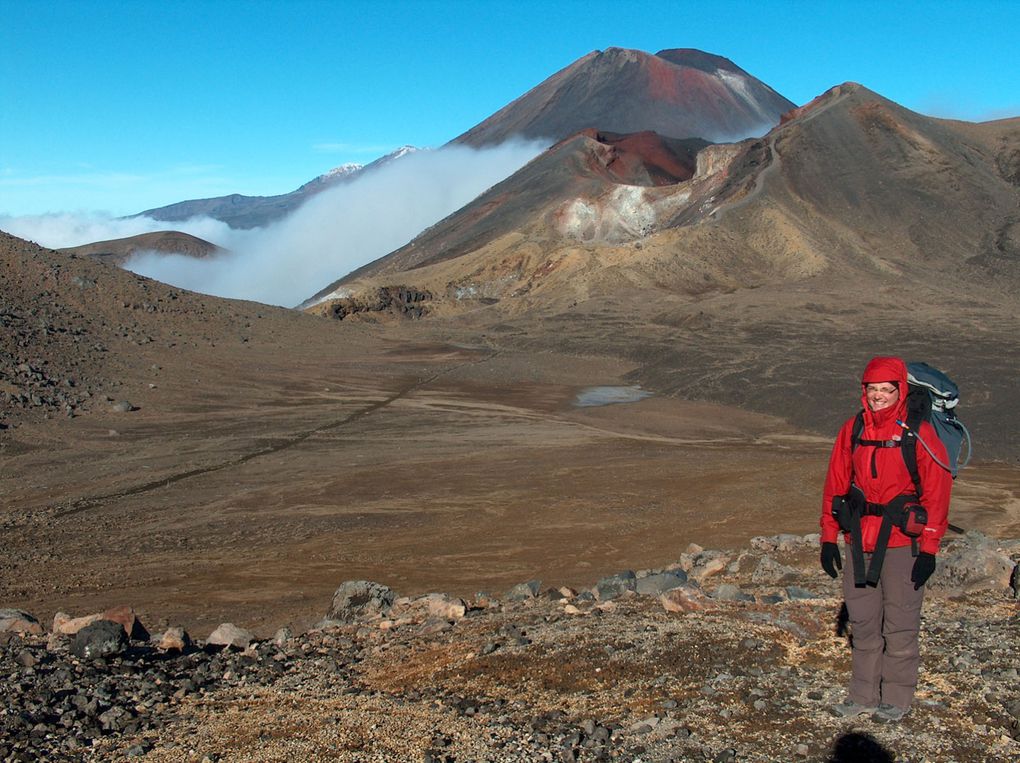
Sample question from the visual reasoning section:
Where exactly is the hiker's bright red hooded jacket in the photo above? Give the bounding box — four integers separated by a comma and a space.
821, 357, 953, 554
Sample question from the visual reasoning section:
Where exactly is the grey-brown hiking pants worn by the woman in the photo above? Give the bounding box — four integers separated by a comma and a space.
843, 546, 924, 708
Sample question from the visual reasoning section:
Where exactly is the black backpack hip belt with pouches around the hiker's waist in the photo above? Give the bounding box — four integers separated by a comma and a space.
832, 485, 928, 586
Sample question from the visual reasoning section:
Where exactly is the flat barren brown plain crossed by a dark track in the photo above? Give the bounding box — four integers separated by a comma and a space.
0, 312, 1020, 635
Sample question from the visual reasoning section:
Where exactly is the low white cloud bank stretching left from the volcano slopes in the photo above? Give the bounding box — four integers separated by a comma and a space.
0, 143, 547, 307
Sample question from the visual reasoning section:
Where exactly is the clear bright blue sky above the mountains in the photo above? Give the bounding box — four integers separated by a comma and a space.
0, 0, 1020, 215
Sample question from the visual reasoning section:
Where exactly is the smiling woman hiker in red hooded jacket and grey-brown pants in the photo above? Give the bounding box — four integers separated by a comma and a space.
821, 357, 953, 721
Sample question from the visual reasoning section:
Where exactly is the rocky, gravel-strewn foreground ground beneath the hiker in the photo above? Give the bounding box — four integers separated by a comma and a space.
0, 533, 1020, 763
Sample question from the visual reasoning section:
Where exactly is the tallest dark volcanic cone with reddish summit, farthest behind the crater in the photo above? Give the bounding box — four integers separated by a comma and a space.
453, 48, 796, 146
